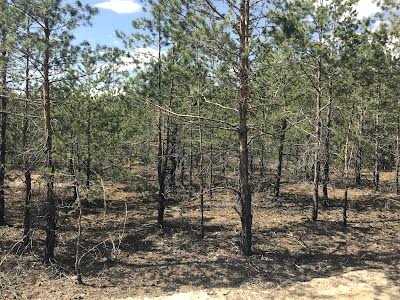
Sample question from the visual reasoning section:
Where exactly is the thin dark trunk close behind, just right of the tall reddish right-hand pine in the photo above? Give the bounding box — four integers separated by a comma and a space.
322, 79, 333, 207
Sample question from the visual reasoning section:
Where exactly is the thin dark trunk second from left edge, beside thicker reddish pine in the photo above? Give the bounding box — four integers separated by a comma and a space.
22, 21, 32, 247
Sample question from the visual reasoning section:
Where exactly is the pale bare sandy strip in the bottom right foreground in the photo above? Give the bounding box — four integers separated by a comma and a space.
125, 270, 400, 300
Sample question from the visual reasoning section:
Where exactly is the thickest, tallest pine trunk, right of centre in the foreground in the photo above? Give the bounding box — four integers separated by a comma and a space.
239, 0, 253, 256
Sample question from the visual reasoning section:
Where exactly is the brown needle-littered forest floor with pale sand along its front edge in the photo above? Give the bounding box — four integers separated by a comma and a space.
0, 168, 400, 300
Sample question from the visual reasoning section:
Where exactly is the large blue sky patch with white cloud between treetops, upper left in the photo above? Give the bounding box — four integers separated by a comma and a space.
75, 0, 144, 47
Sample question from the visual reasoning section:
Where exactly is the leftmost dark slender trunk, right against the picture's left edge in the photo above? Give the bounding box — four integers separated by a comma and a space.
0, 28, 8, 226
